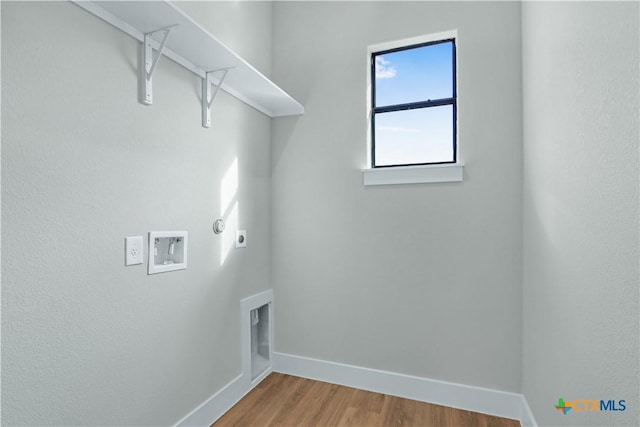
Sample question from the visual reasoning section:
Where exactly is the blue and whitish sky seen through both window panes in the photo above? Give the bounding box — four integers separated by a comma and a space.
375, 43, 453, 166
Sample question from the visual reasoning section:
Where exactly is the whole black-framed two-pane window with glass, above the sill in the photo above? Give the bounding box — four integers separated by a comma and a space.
370, 34, 458, 168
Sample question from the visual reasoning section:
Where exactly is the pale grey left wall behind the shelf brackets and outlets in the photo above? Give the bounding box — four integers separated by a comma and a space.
2, 1, 271, 425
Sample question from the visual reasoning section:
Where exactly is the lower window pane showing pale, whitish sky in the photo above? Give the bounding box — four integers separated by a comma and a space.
374, 105, 454, 166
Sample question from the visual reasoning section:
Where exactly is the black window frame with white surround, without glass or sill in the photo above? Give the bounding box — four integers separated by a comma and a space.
367, 31, 459, 169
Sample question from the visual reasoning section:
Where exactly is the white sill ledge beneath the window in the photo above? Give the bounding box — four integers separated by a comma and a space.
362, 163, 464, 186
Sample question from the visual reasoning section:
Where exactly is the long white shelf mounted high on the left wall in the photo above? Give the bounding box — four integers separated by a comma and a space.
72, 0, 304, 117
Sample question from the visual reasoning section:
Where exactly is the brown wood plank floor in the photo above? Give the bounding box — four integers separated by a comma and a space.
213, 373, 520, 427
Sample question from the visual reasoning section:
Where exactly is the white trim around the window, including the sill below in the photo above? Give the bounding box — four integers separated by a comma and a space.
362, 30, 464, 186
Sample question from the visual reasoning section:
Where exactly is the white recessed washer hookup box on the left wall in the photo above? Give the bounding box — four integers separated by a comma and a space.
149, 231, 188, 274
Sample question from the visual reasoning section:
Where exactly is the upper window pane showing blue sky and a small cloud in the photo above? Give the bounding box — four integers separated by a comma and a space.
375, 42, 453, 107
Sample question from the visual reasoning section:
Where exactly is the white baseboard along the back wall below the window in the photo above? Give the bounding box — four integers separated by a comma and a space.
272, 352, 535, 426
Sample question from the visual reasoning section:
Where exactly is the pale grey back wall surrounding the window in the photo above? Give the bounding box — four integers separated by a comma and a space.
272, 2, 522, 392
